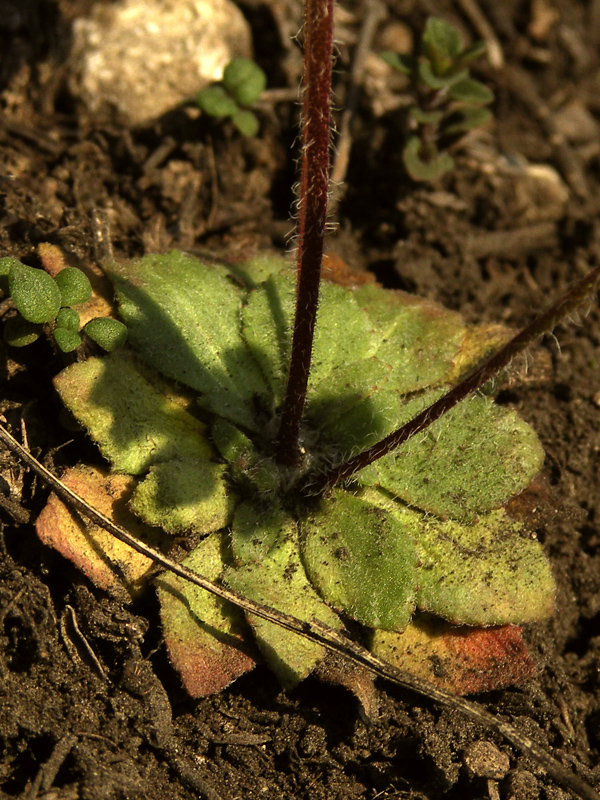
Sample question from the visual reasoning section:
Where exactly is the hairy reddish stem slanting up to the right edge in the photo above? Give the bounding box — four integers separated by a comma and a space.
305, 267, 600, 494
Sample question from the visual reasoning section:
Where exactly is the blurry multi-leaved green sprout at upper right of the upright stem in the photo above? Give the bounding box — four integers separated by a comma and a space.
381, 17, 494, 181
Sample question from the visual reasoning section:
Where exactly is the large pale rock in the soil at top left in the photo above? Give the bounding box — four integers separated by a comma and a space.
71, 0, 252, 125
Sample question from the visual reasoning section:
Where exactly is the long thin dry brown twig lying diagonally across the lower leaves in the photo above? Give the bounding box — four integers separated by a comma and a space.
0, 425, 600, 800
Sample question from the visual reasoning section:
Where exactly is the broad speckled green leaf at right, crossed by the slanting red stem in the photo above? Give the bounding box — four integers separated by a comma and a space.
358, 390, 544, 521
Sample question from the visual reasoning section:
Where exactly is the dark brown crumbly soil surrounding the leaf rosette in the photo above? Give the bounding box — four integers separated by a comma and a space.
0, 0, 600, 800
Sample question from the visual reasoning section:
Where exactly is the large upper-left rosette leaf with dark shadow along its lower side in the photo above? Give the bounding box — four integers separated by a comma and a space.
107, 251, 271, 431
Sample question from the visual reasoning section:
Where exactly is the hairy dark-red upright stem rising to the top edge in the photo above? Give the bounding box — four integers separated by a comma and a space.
277, 0, 333, 467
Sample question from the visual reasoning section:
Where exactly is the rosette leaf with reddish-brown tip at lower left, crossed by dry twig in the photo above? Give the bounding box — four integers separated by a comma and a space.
156, 534, 256, 697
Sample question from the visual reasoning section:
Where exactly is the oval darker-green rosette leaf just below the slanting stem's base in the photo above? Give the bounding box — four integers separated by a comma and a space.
300, 491, 417, 631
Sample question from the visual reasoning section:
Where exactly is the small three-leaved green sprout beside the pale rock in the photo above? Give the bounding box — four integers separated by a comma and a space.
196, 58, 267, 137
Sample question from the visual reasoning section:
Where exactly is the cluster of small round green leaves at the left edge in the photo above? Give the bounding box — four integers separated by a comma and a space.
0, 257, 127, 353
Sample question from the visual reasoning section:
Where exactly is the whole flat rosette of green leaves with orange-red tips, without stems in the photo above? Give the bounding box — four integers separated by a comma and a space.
38, 252, 554, 696
